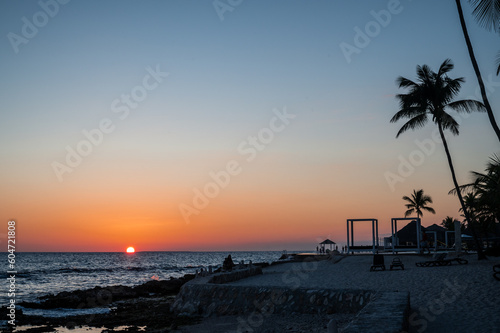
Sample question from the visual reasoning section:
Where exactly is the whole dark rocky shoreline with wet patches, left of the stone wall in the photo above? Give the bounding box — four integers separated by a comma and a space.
2, 274, 198, 332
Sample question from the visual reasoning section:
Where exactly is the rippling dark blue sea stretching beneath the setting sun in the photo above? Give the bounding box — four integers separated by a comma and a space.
0, 251, 281, 305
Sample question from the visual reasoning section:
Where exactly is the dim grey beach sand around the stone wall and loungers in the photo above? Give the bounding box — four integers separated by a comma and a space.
179, 255, 500, 333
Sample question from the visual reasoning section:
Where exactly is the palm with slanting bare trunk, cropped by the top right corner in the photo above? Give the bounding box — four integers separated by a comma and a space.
455, 0, 500, 141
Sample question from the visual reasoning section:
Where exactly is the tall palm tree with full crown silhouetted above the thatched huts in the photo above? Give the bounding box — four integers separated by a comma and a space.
391, 59, 486, 259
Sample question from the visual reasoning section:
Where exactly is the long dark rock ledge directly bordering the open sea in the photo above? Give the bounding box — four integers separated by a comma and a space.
21, 274, 194, 309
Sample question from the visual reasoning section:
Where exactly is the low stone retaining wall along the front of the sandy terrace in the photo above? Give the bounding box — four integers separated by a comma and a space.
173, 283, 375, 316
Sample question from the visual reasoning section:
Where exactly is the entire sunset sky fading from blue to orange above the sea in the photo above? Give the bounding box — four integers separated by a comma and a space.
0, 0, 500, 251
